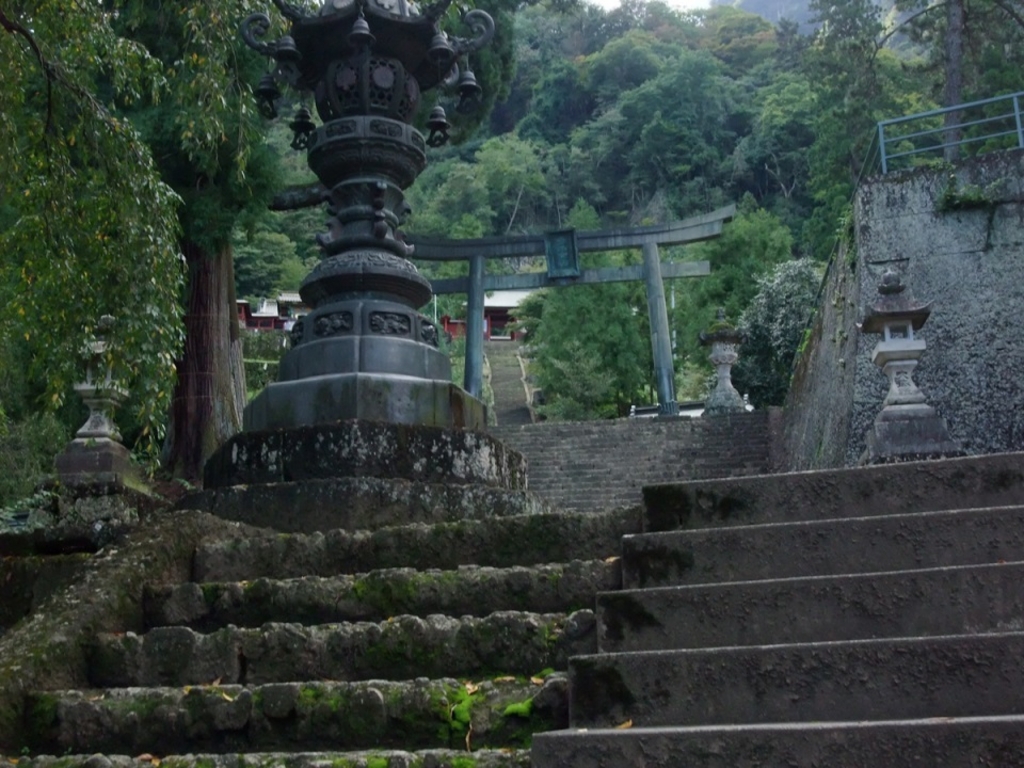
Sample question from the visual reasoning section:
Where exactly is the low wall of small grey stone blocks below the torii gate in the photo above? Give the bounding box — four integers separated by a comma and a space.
488, 411, 775, 511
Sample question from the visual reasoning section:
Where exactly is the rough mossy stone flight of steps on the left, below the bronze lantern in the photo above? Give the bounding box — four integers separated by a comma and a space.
0, 428, 640, 768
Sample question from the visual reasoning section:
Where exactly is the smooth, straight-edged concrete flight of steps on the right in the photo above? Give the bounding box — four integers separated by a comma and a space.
532, 455, 1024, 768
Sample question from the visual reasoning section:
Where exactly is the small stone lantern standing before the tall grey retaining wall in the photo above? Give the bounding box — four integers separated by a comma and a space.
860, 270, 964, 464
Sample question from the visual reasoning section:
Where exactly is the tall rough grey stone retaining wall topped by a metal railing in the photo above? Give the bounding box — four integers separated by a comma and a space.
780, 151, 1024, 469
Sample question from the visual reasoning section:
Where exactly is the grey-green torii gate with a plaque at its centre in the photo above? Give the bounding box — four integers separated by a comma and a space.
409, 205, 736, 416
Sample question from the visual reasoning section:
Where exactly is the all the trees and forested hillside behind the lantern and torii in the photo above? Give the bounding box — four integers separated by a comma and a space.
0, 0, 1024, 499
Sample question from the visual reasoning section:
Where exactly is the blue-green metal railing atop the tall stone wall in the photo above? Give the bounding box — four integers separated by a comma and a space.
878, 91, 1024, 173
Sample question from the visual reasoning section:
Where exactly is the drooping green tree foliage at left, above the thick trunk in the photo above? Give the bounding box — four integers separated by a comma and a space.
0, 0, 284, 456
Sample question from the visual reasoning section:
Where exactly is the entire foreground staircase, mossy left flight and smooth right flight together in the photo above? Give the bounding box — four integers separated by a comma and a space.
6, 433, 1024, 768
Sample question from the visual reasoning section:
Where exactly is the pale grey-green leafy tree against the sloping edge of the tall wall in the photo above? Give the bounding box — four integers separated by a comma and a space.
732, 258, 822, 408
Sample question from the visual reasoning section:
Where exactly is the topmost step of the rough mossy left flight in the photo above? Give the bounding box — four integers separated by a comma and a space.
193, 507, 640, 582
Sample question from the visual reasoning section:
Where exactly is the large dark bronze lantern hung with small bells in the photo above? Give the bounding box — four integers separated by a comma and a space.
242, 0, 495, 431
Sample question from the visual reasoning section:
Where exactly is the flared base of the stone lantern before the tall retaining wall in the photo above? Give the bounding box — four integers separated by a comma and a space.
860, 403, 965, 464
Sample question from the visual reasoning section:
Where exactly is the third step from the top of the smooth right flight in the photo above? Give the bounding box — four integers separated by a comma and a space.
596, 562, 1024, 652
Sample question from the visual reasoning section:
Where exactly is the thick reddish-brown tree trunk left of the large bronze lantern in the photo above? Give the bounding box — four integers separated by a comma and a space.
164, 242, 246, 482
